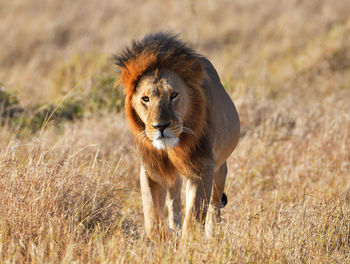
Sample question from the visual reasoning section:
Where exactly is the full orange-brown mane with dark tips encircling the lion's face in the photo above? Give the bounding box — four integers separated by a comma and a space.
114, 32, 208, 185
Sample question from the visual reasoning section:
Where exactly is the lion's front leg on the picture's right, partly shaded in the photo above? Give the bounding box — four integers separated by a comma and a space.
182, 163, 214, 238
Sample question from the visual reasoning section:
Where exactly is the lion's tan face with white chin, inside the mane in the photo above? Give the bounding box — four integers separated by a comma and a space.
132, 70, 191, 149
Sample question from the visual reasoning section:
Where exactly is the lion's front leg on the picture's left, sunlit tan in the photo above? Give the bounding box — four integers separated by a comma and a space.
140, 166, 167, 241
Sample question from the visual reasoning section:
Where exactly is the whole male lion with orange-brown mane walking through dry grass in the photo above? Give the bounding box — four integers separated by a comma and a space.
115, 33, 240, 240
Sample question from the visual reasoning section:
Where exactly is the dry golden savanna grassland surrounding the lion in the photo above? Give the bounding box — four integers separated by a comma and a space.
0, 0, 350, 263
